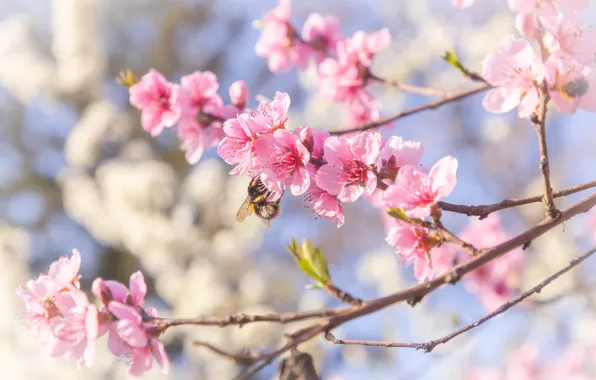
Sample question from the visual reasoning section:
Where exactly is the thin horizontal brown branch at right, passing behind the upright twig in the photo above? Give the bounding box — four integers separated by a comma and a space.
438, 181, 596, 219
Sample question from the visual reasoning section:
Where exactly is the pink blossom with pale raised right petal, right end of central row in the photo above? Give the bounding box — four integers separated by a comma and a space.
384, 156, 458, 218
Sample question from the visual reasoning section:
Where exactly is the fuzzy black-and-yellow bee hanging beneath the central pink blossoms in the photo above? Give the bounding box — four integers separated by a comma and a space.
236, 177, 281, 228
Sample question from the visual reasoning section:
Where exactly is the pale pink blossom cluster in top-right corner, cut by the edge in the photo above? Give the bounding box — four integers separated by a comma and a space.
482, 0, 596, 118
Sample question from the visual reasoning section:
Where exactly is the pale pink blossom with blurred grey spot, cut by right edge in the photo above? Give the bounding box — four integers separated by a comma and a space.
546, 56, 596, 114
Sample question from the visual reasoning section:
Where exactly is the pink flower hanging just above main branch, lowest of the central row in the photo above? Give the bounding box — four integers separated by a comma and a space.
385, 221, 444, 282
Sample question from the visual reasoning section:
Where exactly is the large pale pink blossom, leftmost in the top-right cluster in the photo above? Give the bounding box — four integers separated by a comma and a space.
482, 36, 545, 118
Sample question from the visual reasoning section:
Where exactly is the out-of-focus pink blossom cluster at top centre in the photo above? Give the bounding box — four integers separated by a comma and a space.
255, 0, 391, 125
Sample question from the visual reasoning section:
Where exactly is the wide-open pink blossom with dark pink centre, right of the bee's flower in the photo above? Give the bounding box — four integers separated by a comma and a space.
317, 132, 382, 202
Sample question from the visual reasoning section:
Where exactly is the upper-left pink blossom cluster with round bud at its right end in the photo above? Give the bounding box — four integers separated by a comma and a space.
129, 70, 248, 164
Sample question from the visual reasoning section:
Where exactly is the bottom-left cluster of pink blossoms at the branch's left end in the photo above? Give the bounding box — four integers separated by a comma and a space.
17, 250, 170, 376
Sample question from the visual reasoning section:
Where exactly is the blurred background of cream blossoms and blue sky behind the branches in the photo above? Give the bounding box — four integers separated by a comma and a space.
0, 0, 596, 380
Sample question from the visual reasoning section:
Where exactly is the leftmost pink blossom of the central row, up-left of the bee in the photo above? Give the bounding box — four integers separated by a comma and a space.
217, 113, 270, 175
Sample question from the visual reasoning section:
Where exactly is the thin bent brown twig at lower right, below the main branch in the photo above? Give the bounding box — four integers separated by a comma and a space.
325, 248, 596, 352
